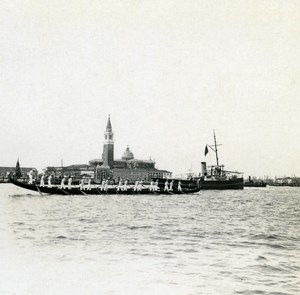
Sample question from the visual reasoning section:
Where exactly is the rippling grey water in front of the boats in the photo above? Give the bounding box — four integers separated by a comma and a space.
0, 184, 300, 295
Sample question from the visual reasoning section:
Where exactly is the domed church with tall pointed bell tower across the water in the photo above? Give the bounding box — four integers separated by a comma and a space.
89, 116, 172, 182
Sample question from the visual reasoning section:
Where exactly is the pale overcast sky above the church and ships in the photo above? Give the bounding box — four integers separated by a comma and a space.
0, 0, 300, 177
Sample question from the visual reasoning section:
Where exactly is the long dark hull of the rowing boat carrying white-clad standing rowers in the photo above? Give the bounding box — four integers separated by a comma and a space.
10, 178, 201, 195
